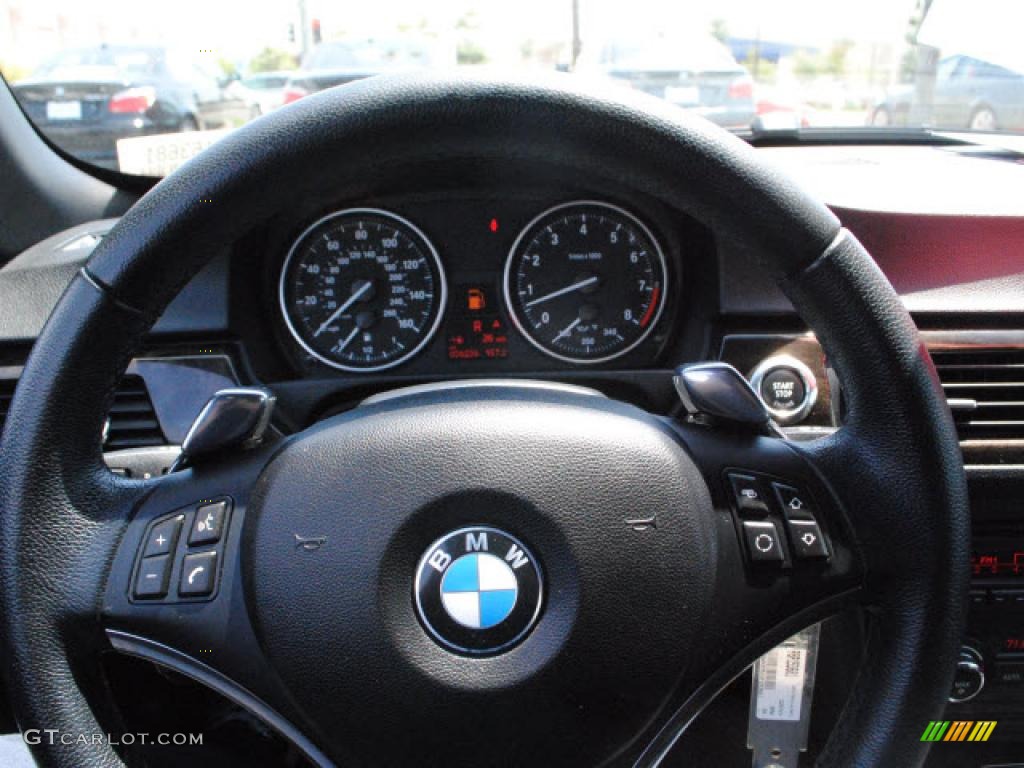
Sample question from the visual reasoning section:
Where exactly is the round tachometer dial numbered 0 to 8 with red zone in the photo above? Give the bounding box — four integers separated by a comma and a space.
505, 201, 668, 364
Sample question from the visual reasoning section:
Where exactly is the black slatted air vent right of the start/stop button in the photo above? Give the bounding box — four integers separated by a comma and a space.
932, 348, 1024, 464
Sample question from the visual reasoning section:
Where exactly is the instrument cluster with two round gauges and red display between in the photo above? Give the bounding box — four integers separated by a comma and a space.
276, 200, 681, 373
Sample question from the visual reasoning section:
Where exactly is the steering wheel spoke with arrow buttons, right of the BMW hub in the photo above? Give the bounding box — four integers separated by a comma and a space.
638, 417, 866, 765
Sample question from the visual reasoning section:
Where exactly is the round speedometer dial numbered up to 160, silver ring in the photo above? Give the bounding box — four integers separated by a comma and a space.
280, 208, 446, 371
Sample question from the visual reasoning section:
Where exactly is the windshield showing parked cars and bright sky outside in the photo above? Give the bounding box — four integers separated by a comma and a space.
0, 0, 1024, 176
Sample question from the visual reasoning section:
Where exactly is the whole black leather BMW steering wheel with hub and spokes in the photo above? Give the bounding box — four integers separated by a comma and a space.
0, 76, 969, 768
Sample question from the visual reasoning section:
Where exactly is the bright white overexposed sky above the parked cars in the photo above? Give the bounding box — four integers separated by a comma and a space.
6, 0, 921, 66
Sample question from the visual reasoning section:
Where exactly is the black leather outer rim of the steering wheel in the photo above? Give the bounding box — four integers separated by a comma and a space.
0, 77, 969, 766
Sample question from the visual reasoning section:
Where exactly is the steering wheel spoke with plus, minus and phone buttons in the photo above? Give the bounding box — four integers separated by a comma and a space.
101, 446, 327, 764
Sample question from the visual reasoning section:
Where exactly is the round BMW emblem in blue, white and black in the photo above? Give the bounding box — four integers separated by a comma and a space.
414, 526, 543, 655
